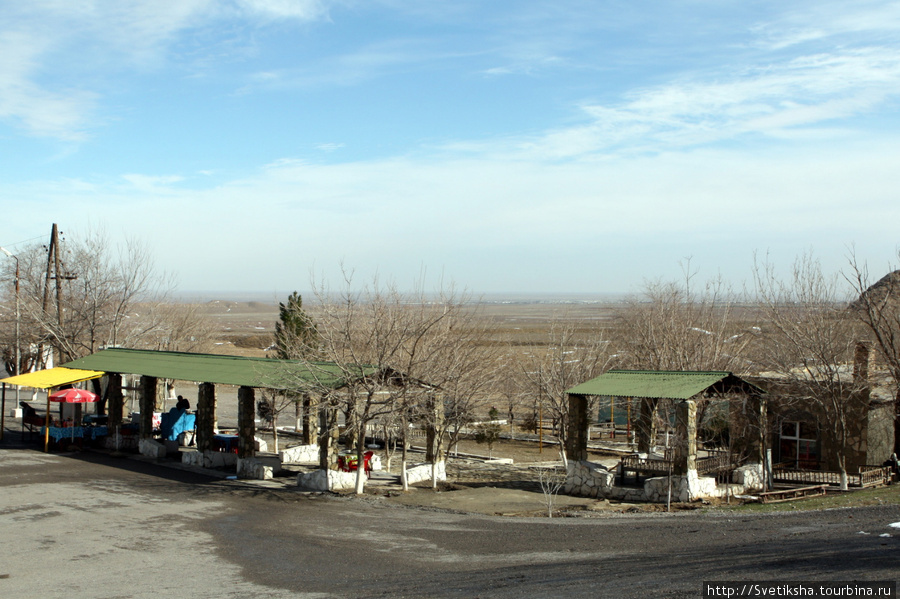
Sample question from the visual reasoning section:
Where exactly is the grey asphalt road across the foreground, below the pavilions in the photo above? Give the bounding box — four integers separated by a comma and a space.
0, 445, 900, 598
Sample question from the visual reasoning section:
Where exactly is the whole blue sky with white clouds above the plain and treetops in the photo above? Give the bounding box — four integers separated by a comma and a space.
0, 0, 900, 295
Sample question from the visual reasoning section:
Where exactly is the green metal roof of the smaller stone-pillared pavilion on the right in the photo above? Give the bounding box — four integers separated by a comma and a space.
567, 370, 762, 399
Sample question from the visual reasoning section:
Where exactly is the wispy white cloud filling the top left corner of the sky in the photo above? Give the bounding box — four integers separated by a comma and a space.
0, 0, 329, 141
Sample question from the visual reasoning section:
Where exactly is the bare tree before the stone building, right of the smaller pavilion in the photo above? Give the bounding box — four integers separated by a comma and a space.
754, 254, 869, 489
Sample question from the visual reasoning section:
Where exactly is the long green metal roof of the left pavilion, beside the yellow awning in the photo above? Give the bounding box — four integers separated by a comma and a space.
64, 348, 375, 389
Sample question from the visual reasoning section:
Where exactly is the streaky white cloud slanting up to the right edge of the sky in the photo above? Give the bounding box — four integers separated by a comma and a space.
446, 39, 900, 160
